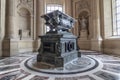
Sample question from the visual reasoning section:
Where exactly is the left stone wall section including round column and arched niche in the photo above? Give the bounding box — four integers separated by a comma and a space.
2, 0, 37, 56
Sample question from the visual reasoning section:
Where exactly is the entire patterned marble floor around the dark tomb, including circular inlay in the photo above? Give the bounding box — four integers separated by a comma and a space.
0, 51, 120, 80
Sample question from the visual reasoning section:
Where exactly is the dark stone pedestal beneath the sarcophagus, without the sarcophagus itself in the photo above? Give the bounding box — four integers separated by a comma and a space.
37, 32, 80, 67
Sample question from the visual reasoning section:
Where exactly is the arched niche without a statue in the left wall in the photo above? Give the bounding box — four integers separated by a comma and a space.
18, 8, 31, 39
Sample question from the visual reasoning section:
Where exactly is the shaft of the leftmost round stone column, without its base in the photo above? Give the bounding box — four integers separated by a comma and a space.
5, 0, 15, 39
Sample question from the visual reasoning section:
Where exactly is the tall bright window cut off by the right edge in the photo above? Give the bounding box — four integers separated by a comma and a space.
112, 0, 120, 36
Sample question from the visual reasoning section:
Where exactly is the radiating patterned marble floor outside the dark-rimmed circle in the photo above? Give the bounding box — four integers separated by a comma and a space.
0, 51, 120, 80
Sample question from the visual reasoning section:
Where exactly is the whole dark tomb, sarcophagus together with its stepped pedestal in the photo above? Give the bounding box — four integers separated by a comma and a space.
37, 10, 80, 67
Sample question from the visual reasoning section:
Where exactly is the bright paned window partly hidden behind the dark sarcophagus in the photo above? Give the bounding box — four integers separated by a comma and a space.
46, 4, 63, 32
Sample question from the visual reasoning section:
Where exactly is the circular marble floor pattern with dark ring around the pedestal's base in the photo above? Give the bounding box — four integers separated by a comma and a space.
24, 56, 99, 75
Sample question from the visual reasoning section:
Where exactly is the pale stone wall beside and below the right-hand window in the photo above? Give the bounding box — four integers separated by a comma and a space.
100, 0, 120, 55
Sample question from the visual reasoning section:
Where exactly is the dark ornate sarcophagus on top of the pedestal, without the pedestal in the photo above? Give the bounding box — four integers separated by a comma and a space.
41, 10, 75, 31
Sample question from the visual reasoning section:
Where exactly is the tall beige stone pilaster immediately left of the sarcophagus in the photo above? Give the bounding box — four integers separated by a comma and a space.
35, 0, 46, 51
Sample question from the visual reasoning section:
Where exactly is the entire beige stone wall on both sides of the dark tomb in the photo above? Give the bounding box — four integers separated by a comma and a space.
0, 0, 120, 56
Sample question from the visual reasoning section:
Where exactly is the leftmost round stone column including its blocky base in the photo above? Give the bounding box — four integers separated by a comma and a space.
2, 0, 18, 56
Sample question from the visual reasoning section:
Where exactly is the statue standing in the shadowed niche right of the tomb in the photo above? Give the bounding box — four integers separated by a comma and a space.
78, 16, 89, 36
